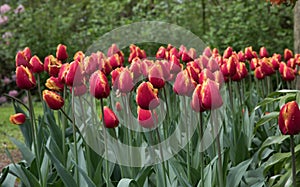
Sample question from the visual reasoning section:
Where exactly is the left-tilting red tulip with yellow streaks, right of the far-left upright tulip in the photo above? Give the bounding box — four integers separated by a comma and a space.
43, 90, 64, 110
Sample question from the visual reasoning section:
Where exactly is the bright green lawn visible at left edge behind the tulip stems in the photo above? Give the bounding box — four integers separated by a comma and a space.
0, 103, 43, 149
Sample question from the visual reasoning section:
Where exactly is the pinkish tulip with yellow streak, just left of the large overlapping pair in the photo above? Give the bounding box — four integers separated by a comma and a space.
173, 70, 197, 97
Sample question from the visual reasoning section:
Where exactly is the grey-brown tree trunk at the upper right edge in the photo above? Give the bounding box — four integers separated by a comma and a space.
294, 1, 300, 90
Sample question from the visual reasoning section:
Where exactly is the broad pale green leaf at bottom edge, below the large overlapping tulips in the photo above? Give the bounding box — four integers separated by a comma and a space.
226, 158, 252, 187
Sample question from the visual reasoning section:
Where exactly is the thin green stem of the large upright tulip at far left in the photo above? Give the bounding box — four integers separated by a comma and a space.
27, 90, 44, 184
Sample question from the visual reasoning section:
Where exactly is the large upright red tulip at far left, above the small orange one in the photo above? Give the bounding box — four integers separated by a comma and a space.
16, 65, 36, 90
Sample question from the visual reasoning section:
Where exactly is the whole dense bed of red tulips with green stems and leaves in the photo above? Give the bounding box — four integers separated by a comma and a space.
0, 44, 300, 186
